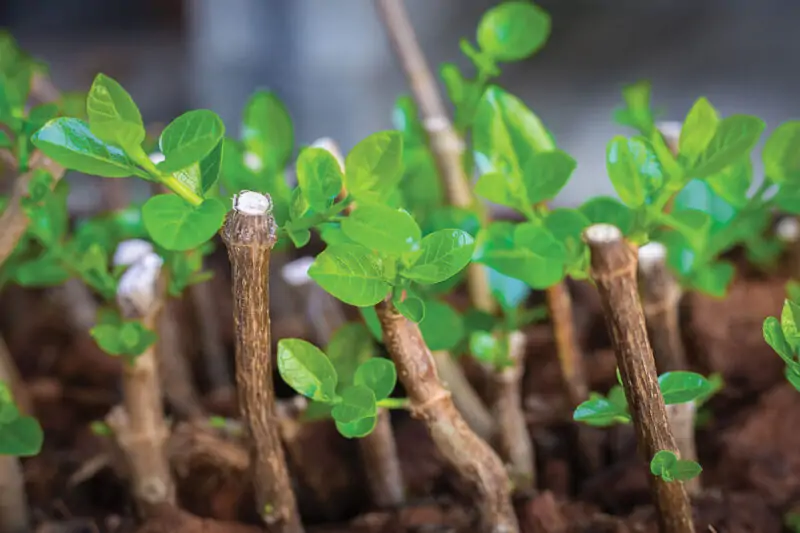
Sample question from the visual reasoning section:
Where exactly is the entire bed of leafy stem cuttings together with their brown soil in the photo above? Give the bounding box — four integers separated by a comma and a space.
0, 0, 800, 533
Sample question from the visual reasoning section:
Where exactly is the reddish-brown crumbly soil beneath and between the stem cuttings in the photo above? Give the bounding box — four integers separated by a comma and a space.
0, 246, 800, 533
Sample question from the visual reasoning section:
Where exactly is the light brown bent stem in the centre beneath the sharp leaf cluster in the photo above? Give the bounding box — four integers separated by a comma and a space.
376, 301, 519, 533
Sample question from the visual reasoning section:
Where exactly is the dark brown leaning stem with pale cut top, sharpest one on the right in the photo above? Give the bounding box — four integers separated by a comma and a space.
584, 224, 694, 533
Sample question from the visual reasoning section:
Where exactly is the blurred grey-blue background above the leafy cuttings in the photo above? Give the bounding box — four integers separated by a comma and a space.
0, 0, 800, 205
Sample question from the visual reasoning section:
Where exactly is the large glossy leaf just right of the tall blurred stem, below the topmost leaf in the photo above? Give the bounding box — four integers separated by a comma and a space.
473, 85, 555, 179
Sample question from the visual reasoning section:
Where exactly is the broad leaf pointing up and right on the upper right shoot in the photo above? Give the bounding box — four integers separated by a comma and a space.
684, 115, 765, 178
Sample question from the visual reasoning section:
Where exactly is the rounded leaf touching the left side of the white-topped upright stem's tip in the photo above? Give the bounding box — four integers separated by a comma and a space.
142, 194, 227, 251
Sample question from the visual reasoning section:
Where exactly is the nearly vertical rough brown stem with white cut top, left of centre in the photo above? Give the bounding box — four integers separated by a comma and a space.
221, 192, 303, 533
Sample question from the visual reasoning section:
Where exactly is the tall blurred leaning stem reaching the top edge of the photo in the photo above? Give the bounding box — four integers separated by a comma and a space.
376, 0, 496, 313
